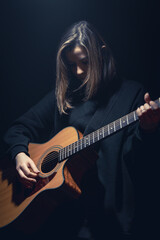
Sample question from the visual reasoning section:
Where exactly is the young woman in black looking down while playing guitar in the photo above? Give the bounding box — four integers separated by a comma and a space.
4, 21, 160, 239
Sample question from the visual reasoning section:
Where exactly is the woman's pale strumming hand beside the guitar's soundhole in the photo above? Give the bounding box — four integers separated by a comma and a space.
15, 152, 39, 188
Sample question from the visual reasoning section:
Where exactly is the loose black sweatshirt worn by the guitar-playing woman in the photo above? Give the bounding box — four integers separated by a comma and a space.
4, 81, 160, 236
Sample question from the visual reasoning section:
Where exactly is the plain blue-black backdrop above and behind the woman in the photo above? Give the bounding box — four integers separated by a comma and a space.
0, 0, 160, 141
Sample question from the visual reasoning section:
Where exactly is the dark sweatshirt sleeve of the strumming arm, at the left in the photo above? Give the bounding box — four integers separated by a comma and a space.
3, 91, 55, 159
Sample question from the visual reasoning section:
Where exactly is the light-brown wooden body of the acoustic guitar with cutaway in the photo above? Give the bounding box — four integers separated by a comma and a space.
0, 127, 97, 233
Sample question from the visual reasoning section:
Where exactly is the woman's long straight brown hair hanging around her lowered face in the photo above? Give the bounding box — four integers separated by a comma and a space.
56, 21, 115, 114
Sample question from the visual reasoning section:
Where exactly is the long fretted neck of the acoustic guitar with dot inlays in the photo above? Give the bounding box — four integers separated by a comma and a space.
59, 98, 160, 162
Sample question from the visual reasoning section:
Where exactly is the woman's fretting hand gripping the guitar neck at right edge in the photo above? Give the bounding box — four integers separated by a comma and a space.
136, 93, 160, 132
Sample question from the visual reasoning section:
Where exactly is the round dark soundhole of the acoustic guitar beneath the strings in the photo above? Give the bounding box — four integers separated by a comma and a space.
41, 151, 58, 173
